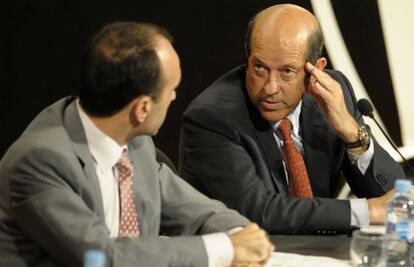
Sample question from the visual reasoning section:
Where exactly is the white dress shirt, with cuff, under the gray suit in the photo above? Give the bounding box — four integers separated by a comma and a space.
76, 100, 234, 267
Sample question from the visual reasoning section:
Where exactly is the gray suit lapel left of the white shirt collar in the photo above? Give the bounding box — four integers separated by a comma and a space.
63, 97, 105, 220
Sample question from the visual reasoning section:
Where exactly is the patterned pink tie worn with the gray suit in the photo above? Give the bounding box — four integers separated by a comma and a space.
115, 149, 139, 237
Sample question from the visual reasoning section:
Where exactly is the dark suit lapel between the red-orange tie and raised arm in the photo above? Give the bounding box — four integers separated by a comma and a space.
299, 94, 330, 197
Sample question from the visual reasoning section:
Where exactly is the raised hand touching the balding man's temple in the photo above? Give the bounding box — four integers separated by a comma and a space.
305, 62, 359, 147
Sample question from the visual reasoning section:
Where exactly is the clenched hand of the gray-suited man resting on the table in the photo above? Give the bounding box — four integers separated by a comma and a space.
230, 223, 275, 267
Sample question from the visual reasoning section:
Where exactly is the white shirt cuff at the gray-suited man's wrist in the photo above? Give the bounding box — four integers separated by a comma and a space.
201, 233, 234, 267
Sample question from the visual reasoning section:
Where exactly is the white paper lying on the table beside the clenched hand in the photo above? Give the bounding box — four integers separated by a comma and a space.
265, 252, 351, 267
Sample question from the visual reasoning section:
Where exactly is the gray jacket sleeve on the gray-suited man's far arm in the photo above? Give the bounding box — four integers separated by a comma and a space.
160, 158, 249, 235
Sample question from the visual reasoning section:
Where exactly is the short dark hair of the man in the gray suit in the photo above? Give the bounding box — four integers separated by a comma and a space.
79, 22, 172, 116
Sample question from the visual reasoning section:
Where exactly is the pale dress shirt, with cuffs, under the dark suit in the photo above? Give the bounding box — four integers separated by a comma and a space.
273, 101, 374, 227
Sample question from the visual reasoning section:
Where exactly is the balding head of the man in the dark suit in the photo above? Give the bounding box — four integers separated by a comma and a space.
246, 5, 326, 122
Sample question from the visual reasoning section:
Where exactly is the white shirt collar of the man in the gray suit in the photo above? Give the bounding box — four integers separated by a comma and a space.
76, 99, 126, 169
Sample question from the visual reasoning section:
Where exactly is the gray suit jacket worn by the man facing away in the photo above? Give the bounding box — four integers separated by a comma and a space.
0, 97, 248, 267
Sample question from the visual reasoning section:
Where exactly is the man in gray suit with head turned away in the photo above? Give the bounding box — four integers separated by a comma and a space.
0, 22, 274, 267
